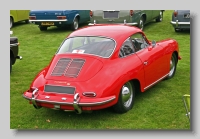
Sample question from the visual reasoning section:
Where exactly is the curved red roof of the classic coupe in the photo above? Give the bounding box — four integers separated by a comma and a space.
68, 24, 142, 40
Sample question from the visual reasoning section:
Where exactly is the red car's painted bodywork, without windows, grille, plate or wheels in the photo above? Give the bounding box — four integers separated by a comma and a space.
23, 25, 180, 111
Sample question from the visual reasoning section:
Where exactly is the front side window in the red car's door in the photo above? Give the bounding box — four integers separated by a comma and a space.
131, 33, 149, 52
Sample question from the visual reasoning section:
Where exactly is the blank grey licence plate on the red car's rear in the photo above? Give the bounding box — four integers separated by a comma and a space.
44, 85, 75, 94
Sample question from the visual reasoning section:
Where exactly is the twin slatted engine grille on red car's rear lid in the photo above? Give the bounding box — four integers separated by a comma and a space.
51, 58, 85, 77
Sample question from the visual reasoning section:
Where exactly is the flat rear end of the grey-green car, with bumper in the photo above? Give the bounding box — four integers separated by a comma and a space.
89, 10, 137, 25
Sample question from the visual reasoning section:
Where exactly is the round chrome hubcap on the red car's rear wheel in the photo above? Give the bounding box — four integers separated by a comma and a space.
122, 83, 133, 107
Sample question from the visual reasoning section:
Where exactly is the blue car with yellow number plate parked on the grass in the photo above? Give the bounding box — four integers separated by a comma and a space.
29, 10, 90, 31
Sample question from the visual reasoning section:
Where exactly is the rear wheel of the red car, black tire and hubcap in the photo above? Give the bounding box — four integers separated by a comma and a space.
113, 82, 135, 113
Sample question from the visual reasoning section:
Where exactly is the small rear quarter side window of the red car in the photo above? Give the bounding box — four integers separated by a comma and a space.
119, 38, 135, 57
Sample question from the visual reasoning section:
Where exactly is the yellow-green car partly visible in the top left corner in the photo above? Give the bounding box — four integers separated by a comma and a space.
10, 10, 30, 28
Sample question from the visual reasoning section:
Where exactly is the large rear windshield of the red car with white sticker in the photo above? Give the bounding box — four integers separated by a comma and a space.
57, 36, 115, 58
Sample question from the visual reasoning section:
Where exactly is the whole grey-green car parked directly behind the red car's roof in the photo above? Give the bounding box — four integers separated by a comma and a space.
89, 10, 164, 30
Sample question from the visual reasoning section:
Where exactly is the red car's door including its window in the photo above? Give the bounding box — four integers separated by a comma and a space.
131, 33, 167, 89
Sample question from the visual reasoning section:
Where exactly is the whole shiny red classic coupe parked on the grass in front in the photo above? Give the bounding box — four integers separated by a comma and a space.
23, 25, 181, 114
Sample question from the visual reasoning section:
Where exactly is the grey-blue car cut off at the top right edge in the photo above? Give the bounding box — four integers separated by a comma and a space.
170, 10, 190, 32
